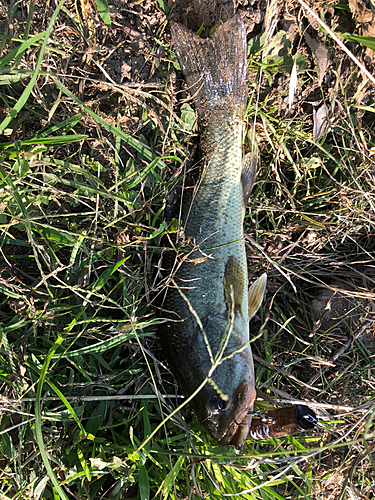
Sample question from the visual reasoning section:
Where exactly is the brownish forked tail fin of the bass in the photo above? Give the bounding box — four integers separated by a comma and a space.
171, 16, 247, 118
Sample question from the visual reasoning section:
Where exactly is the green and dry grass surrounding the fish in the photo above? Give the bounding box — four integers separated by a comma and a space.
0, 3, 375, 500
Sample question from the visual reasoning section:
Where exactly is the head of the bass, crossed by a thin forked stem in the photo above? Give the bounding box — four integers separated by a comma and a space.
177, 314, 256, 447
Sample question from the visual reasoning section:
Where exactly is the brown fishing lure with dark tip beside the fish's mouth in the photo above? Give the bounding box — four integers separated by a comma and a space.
248, 405, 319, 440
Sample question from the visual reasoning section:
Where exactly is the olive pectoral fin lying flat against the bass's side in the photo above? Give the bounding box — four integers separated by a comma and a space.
224, 255, 245, 313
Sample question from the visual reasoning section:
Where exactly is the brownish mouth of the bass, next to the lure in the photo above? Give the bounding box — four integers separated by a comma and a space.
219, 381, 256, 448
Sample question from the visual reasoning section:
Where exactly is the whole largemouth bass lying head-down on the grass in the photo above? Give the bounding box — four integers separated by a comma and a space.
162, 17, 266, 446
